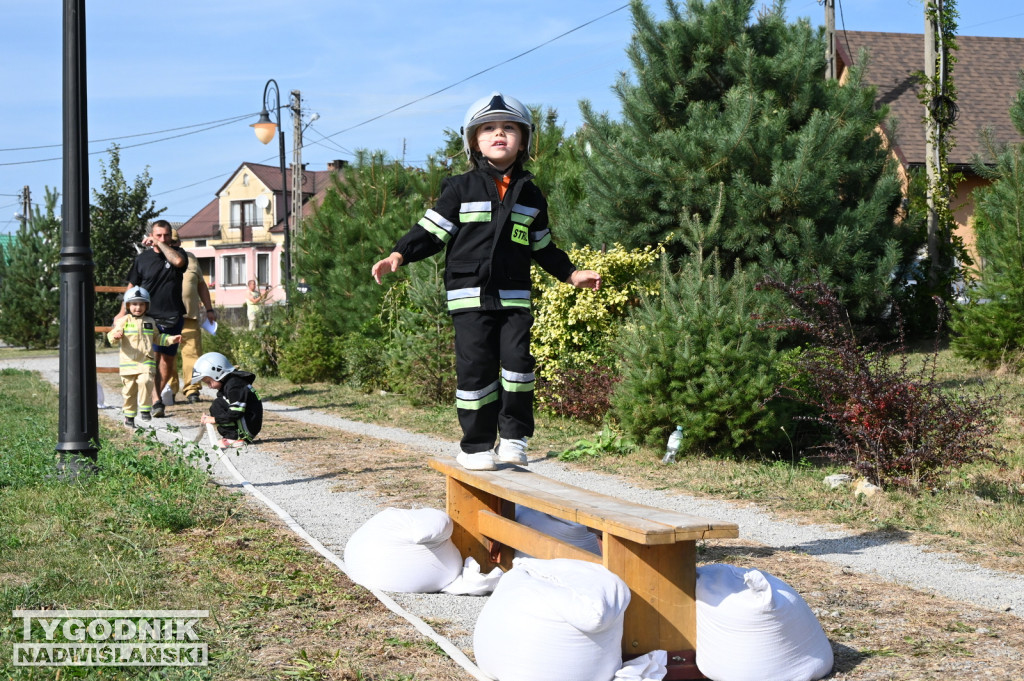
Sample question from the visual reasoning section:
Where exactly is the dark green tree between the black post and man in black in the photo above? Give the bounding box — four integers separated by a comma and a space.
89, 144, 167, 323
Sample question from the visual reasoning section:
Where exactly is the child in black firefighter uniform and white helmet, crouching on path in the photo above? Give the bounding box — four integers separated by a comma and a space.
191, 352, 263, 450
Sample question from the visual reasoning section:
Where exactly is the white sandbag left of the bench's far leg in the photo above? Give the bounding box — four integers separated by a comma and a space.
345, 508, 462, 593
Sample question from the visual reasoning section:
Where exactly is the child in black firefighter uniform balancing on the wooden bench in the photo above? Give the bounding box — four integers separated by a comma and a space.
371, 92, 601, 470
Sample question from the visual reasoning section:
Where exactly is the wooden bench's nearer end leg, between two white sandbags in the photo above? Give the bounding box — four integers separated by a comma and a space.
604, 533, 696, 662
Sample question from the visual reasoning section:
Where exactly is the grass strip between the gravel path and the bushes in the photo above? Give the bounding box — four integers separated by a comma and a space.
260, 350, 1024, 572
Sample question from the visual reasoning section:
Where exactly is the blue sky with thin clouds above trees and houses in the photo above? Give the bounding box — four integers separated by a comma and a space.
0, 0, 1024, 232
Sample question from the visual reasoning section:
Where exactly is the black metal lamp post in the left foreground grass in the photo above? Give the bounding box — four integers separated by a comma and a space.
56, 0, 99, 461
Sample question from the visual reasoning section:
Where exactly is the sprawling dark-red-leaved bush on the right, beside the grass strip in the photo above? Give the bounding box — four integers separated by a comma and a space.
759, 279, 998, 490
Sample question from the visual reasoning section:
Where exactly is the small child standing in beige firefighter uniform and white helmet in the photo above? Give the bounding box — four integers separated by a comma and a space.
106, 286, 181, 428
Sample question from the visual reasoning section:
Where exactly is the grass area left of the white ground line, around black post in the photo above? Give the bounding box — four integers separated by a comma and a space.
0, 370, 457, 680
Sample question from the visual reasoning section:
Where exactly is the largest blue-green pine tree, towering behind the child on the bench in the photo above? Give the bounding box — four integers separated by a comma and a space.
574, 0, 909, 316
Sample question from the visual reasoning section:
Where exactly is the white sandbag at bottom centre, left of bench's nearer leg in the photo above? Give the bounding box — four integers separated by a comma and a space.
473, 558, 630, 681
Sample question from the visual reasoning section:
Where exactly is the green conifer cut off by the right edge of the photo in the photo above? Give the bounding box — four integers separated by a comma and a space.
950, 82, 1024, 371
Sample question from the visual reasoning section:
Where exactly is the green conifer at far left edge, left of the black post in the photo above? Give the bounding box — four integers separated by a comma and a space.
0, 187, 61, 349
